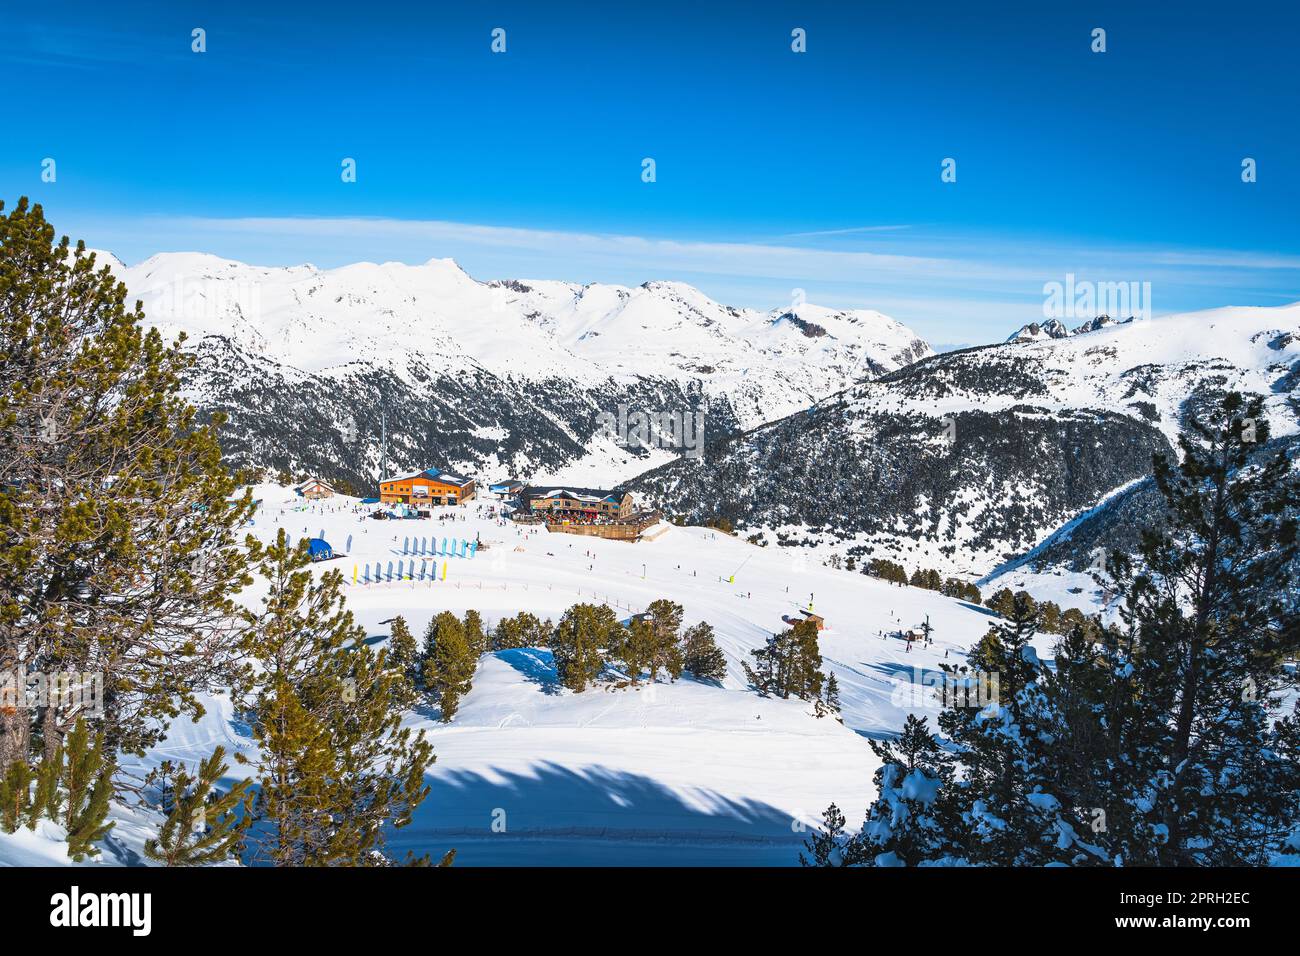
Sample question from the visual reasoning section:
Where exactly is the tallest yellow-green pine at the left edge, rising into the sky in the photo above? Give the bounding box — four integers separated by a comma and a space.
0, 199, 252, 778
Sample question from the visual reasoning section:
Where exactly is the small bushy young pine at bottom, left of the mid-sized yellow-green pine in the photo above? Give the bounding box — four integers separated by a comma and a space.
144, 747, 252, 866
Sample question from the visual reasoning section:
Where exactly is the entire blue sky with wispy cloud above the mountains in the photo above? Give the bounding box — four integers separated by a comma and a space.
0, 0, 1300, 342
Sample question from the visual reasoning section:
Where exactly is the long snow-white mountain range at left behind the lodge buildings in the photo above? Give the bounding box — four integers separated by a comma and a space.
99, 254, 931, 488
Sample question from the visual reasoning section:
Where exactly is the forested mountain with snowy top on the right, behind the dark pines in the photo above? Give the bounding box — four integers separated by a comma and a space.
636, 304, 1300, 576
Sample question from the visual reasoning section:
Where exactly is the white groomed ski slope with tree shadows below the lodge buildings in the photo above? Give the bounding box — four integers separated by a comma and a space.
14, 485, 1047, 866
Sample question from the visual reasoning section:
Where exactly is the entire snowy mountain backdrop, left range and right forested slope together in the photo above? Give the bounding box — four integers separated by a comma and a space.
98, 254, 1300, 587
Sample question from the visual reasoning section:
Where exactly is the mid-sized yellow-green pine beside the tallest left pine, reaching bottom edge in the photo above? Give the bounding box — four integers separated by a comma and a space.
237, 529, 436, 866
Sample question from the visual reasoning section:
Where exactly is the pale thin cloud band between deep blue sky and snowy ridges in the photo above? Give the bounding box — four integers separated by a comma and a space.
68, 216, 1300, 341
